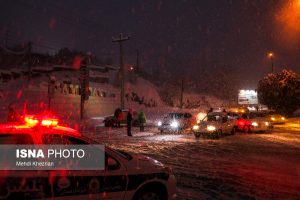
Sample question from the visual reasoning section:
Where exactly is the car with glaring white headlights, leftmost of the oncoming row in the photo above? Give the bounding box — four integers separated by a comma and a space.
157, 112, 196, 133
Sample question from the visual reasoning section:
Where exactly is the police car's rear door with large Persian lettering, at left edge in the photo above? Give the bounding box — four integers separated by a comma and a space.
0, 133, 52, 199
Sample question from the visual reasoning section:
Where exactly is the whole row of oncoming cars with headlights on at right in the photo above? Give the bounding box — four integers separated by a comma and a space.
157, 108, 278, 139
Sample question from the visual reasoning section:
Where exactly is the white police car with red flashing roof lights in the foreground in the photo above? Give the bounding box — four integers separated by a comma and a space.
0, 117, 176, 200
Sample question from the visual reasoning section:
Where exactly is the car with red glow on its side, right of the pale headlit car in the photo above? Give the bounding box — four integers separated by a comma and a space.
236, 112, 272, 133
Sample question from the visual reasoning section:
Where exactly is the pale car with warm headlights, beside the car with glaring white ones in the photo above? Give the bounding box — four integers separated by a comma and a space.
192, 112, 236, 138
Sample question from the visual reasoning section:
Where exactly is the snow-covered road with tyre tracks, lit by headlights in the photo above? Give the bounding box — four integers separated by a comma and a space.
87, 128, 300, 199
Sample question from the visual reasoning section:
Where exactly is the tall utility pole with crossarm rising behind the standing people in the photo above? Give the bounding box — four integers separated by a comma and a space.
112, 33, 130, 109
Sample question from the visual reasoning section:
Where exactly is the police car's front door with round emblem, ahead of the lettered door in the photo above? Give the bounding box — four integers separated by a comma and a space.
45, 135, 127, 200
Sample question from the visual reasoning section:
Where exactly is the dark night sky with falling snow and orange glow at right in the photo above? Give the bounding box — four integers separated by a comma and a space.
0, 0, 300, 87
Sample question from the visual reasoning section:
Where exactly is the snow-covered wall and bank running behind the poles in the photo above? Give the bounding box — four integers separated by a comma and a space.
0, 66, 229, 121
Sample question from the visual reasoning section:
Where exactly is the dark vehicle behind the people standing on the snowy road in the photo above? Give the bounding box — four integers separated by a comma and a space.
103, 110, 139, 127
